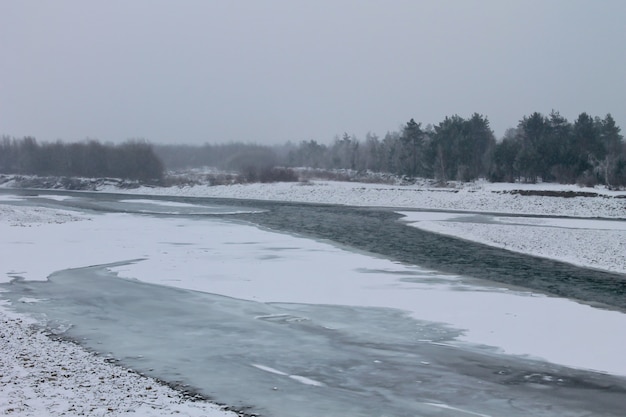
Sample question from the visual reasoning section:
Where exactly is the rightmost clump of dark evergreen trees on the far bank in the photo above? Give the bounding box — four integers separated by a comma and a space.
492, 111, 626, 186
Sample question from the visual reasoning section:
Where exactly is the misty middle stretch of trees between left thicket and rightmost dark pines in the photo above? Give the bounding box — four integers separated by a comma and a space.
155, 114, 496, 181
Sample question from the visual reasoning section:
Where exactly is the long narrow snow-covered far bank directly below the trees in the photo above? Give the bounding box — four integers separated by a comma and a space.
101, 181, 626, 219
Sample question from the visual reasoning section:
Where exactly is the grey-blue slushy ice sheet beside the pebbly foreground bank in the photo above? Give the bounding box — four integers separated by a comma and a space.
0, 265, 626, 417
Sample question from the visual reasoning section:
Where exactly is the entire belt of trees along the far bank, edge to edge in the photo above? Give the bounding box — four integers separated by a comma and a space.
0, 111, 626, 188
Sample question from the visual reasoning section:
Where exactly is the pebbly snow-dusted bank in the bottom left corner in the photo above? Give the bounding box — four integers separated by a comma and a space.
0, 305, 236, 417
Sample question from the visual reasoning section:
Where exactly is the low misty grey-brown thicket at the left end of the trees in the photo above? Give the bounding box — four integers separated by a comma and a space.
0, 136, 164, 184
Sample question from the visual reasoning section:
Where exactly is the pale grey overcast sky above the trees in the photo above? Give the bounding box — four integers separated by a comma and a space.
0, 0, 626, 143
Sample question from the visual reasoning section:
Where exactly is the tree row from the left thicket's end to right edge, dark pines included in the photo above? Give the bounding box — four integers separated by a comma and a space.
155, 111, 626, 187
